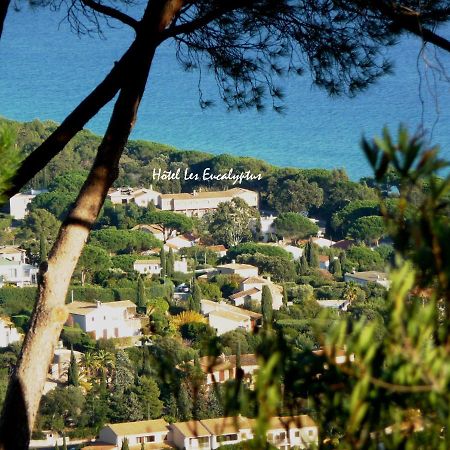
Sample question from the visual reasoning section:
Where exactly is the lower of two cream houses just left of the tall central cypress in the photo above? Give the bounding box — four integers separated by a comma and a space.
201, 300, 262, 336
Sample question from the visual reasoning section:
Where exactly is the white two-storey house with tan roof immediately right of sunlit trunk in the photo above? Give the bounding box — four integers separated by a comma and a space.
67, 300, 142, 339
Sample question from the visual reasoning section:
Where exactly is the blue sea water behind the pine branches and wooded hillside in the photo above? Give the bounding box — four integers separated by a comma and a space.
0, 7, 450, 179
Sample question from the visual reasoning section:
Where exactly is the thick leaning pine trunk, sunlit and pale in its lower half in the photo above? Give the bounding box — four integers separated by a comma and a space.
0, 0, 183, 450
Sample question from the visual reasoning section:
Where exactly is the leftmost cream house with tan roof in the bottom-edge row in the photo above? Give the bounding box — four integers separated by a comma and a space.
99, 419, 170, 449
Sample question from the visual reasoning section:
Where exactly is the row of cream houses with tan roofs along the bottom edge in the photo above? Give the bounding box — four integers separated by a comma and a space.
84, 415, 319, 450
